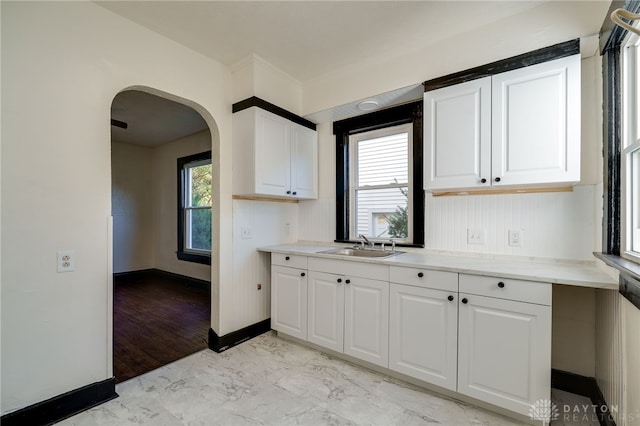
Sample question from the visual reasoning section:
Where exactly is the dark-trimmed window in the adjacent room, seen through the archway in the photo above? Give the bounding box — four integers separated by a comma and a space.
177, 151, 212, 264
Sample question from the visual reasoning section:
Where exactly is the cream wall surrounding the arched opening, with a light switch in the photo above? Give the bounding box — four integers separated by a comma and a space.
0, 2, 233, 414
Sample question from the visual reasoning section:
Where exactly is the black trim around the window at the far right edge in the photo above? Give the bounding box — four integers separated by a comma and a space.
594, 0, 640, 309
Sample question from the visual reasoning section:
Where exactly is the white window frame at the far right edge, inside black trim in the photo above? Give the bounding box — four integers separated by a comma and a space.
620, 32, 640, 262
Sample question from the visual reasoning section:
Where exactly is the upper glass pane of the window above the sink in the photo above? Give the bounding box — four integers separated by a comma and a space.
357, 133, 409, 187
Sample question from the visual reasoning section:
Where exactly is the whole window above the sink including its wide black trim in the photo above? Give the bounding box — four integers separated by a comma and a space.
334, 102, 424, 247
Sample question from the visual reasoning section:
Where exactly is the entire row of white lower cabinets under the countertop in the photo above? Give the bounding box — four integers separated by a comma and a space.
271, 253, 551, 415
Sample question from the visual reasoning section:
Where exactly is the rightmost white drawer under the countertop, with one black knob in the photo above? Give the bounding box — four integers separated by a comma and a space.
459, 274, 551, 306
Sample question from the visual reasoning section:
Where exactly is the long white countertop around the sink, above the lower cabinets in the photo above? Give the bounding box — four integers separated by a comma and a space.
258, 242, 618, 290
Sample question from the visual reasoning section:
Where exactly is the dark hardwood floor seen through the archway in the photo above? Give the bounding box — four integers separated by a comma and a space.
113, 270, 211, 383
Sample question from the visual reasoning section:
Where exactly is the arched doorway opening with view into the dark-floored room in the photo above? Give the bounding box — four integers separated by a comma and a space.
111, 87, 217, 382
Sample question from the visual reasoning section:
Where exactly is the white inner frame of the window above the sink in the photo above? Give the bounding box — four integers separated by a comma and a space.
349, 123, 413, 243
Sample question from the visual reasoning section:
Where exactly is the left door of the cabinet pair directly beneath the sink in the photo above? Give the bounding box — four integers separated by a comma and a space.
307, 271, 344, 352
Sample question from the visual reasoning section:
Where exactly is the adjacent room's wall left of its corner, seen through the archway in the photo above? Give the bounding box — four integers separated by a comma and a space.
111, 141, 156, 273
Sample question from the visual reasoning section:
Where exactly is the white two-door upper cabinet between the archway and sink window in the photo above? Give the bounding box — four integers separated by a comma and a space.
233, 106, 318, 199
